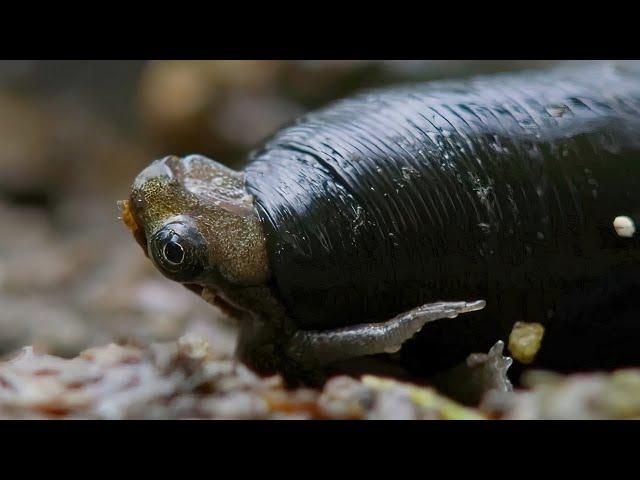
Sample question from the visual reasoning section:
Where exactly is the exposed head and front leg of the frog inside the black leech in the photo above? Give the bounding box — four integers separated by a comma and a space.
123, 156, 484, 383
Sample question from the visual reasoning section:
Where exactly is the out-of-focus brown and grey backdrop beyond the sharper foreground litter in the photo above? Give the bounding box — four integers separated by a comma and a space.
0, 60, 572, 357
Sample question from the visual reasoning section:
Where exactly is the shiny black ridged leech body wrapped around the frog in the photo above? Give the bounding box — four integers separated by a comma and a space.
245, 63, 640, 370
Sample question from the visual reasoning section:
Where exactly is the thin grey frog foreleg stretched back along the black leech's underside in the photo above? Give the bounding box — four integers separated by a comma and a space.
288, 300, 485, 365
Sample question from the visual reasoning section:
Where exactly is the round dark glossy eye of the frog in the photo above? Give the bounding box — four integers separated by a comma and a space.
149, 222, 206, 282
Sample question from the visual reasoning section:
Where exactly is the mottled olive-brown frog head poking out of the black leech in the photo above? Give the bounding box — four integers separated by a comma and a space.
125, 155, 270, 291
